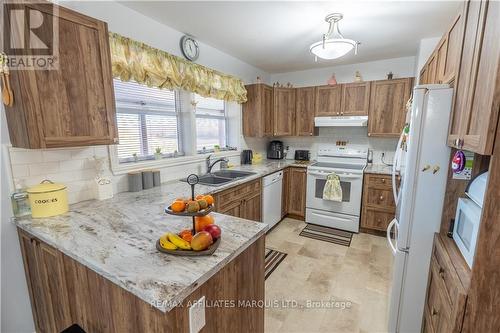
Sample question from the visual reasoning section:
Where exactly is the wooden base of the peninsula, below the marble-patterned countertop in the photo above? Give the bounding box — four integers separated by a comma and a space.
18, 229, 264, 333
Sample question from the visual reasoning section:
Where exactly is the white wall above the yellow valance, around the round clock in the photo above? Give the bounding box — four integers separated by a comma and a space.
60, 0, 269, 83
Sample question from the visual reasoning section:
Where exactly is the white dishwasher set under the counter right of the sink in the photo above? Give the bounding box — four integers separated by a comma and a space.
262, 171, 283, 229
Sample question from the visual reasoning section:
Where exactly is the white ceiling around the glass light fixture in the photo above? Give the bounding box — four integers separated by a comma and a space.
121, 0, 461, 73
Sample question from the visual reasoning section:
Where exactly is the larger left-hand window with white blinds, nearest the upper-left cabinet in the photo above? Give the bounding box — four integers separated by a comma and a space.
114, 80, 182, 163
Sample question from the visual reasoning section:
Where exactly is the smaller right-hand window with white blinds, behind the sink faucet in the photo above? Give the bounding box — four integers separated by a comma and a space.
195, 94, 227, 152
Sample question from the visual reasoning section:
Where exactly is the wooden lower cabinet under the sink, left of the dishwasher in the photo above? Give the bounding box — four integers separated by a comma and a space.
214, 178, 262, 222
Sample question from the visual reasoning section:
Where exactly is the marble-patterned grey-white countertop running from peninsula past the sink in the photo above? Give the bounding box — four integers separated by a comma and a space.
14, 160, 306, 312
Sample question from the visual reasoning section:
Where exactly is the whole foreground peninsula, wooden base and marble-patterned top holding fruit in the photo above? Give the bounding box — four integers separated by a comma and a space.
15, 178, 267, 332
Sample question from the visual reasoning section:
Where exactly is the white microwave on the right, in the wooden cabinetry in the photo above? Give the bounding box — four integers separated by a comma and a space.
453, 198, 481, 268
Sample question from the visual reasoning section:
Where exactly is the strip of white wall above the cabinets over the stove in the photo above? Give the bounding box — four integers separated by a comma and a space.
270, 57, 415, 87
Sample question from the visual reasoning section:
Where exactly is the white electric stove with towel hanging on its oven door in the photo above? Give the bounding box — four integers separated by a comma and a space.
306, 145, 368, 232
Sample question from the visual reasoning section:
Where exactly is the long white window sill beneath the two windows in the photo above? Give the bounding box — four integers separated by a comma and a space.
110, 150, 241, 176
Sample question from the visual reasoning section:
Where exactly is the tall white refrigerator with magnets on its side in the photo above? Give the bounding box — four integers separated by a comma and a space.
387, 85, 453, 333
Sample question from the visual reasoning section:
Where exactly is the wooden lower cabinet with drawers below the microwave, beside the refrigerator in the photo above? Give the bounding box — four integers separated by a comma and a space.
422, 234, 468, 333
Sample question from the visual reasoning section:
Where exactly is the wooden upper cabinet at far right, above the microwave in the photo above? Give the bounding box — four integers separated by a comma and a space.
448, 0, 500, 155
